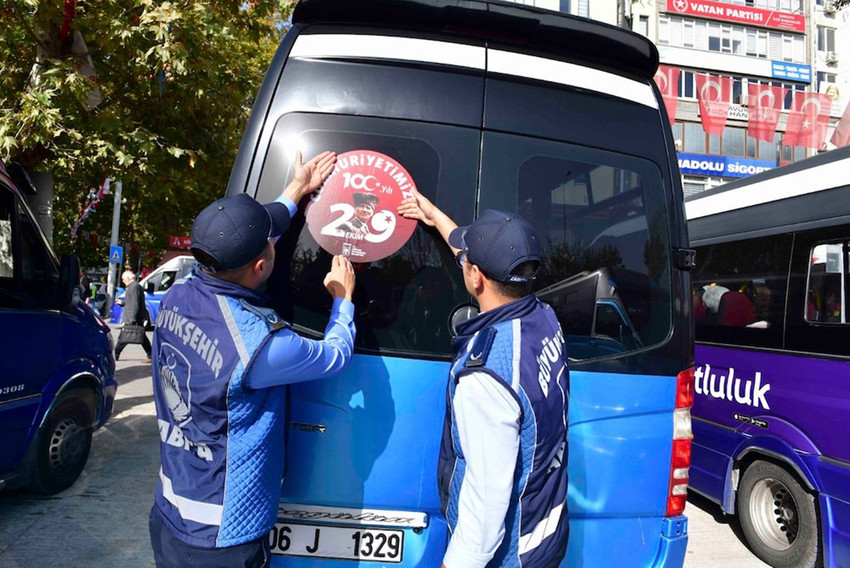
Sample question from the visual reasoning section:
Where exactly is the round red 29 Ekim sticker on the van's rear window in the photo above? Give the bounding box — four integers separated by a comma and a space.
307, 150, 416, 262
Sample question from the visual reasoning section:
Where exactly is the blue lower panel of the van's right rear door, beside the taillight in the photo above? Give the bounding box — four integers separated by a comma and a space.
566, 370, 676, 567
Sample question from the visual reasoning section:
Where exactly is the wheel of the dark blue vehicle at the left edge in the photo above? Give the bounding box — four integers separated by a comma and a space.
29, 390, 93, 495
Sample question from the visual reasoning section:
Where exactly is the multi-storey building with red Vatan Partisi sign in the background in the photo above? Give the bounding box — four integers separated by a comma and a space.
506, 0, 850, 194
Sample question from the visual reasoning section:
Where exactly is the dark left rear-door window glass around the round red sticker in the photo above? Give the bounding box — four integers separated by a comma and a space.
257, 113, 479, 359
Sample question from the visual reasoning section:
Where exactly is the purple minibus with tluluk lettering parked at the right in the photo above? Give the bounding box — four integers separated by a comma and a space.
686, 147, 850, 567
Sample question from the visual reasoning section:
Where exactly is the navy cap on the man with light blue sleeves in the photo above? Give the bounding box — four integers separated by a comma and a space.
191, 193, 289, 272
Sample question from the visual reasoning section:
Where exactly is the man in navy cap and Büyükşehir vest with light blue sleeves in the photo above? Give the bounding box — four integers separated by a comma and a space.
150, 152, 355, 568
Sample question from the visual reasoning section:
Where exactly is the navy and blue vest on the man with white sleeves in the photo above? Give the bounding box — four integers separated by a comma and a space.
438, 295, 569, 568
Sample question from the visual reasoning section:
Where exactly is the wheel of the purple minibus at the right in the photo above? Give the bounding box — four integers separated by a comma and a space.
738, 461, 818, 568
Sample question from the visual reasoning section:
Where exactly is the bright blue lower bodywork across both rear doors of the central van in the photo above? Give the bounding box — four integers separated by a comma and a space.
275, 355, 687, 567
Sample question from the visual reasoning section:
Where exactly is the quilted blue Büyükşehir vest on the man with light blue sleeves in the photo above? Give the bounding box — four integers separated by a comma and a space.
153, 270, 286, 548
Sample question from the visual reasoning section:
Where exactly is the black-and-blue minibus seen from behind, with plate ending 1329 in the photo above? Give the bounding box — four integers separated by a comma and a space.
227, 0, 693, 568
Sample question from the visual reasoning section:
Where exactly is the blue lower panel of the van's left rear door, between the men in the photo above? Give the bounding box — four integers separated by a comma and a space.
281, 355, 449, 567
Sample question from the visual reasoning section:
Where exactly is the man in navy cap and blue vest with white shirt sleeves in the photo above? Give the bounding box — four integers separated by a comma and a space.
399, 192, 569, 568
